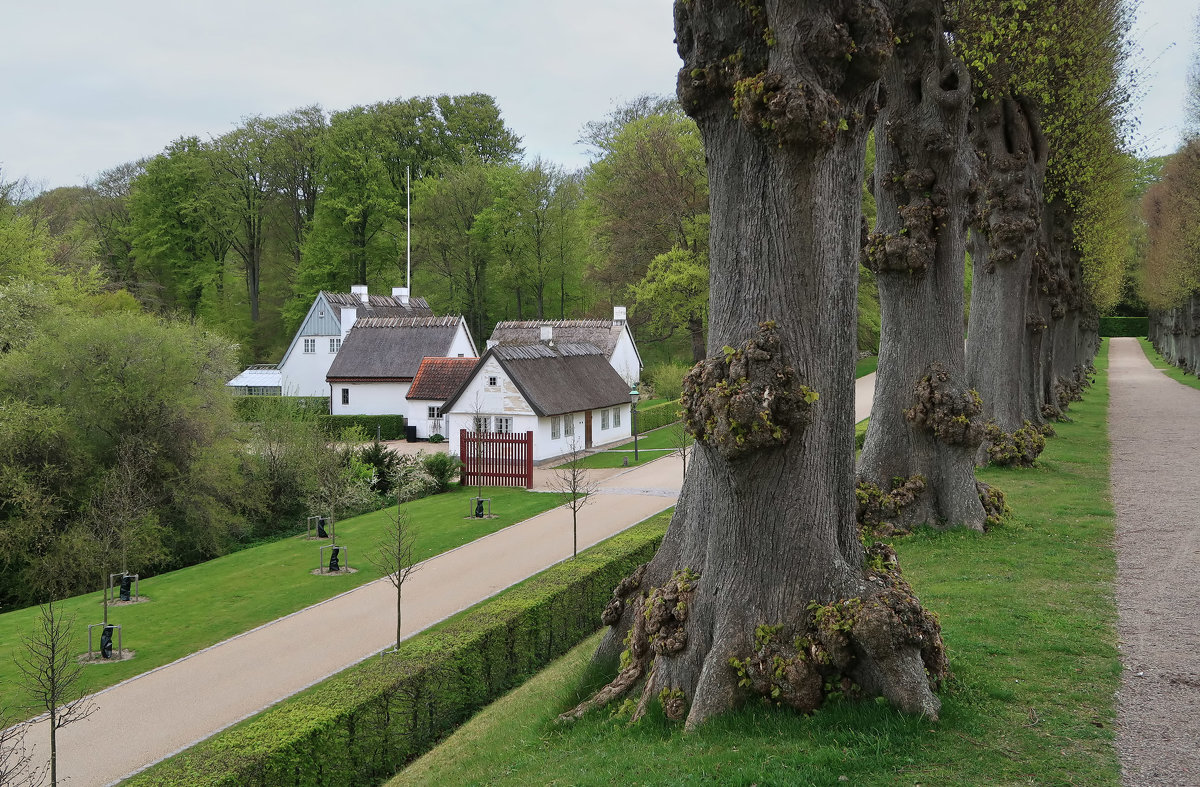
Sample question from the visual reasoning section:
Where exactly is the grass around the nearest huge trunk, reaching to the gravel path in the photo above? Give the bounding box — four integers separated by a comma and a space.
391, 347, 1121, 786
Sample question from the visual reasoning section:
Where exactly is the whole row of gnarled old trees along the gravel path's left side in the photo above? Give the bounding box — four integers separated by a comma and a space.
576, 0, 1128, 727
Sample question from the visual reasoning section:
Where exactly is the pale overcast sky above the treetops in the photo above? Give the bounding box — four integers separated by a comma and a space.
0, 0, 1200, 188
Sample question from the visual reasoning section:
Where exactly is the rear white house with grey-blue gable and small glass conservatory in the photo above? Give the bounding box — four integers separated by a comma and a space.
226, 284, 433, 396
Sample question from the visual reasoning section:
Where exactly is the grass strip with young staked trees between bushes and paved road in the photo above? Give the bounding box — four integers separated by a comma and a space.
0, 486, 560, 715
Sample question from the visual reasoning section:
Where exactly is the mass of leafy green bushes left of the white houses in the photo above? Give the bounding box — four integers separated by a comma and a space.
0, 182, 398, 609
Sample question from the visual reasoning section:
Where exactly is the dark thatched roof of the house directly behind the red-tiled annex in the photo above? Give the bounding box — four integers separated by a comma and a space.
325, 317, 462, 383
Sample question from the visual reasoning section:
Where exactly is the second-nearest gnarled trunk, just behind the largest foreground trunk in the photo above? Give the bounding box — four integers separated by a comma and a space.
858, 0, 986, 530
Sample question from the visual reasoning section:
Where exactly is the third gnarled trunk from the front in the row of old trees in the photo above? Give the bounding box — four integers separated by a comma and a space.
967, 98, 1046, 462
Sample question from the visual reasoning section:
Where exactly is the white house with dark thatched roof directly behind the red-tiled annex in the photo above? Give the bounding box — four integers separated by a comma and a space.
325, 310, 478, 416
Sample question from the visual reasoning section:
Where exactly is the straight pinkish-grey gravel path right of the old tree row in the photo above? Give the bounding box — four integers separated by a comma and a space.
1109, 338, 1200, 787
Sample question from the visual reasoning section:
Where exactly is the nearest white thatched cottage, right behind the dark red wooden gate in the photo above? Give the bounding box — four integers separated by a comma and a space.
442, 343, 632, 462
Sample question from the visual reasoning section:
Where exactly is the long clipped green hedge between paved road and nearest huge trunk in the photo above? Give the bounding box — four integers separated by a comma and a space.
126, 516, 667, 787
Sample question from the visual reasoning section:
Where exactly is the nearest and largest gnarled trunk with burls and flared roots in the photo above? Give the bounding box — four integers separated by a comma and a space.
566, 0, 946, 727
